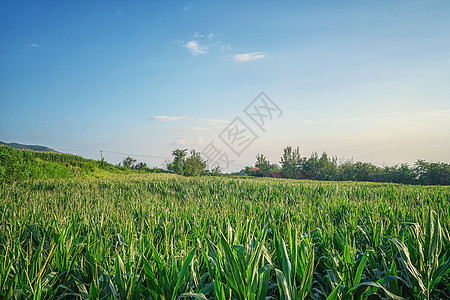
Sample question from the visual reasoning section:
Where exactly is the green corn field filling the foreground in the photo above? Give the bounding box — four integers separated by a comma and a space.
0, 174, 450, 300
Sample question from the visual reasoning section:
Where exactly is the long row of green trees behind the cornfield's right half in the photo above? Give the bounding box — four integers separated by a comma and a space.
246, 146, 450, 185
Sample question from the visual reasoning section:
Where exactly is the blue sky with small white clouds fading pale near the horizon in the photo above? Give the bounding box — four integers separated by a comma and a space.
0, 0, 450, 171
